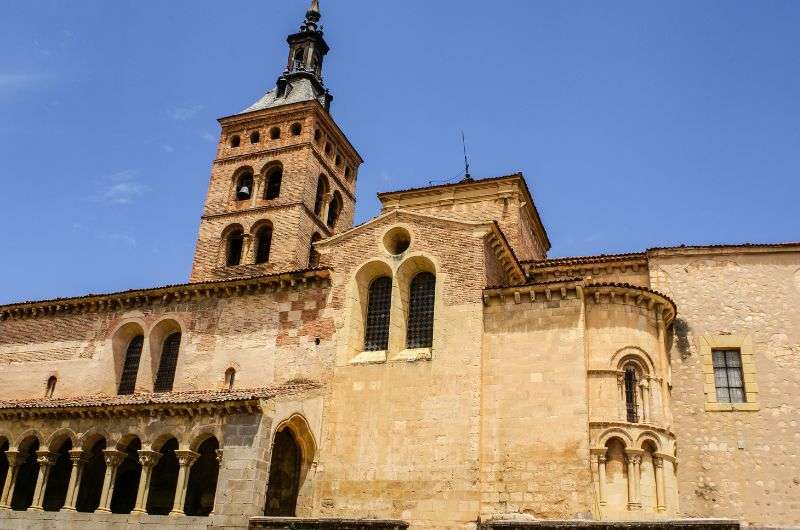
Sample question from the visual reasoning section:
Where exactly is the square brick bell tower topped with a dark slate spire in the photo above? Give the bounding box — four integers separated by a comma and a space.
190, 0, 363, 282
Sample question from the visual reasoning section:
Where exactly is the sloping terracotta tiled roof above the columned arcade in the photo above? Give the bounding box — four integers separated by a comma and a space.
0, 381, 321, 410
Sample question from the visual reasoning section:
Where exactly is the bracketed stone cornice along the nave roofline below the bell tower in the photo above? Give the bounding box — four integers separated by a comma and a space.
0, 268, 330, 321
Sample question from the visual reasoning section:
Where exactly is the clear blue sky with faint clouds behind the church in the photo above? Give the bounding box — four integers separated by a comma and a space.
0, 0, 800, 302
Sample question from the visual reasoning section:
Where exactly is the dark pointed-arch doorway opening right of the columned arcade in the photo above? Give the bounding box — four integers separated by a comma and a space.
264, 427, 302, 517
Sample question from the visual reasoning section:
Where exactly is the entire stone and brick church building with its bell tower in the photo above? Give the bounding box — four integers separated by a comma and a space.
0, 0, 800, 529
